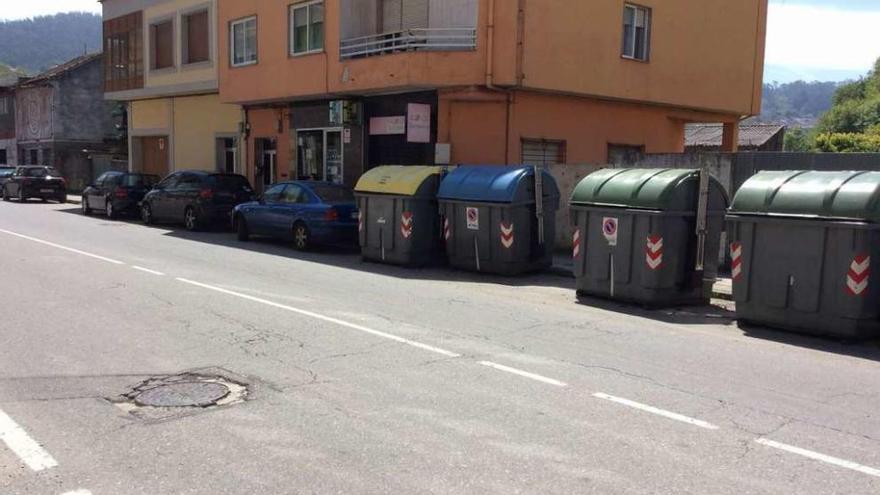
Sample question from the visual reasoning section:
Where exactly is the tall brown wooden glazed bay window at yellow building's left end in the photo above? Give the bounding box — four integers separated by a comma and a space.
104, 12, 144, 92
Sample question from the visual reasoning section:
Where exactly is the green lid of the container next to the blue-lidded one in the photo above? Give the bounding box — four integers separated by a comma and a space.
571, 168, 700, 210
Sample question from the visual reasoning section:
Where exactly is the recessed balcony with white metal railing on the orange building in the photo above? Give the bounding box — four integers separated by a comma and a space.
339, 0, 478, 59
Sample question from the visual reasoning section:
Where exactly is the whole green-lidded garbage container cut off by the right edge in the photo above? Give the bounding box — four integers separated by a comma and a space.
727, 171, 880, 339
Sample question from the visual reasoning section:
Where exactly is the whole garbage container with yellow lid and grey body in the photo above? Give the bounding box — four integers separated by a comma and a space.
355, 165, 446, 266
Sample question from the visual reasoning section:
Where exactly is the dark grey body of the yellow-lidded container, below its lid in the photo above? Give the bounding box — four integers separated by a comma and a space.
356, 176, 445, 267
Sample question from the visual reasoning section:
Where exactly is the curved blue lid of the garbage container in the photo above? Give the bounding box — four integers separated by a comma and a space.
437, 165, 559, 203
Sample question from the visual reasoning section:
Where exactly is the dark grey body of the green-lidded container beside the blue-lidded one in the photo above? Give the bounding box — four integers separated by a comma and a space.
571, 206, 724, 306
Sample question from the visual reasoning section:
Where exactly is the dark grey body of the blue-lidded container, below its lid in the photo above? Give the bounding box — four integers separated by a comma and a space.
440, 201, 559, 275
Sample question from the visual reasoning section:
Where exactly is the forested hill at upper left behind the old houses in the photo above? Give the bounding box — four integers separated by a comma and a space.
0, 12, 101, 74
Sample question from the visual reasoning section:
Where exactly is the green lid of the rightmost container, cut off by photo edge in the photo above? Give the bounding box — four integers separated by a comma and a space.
730, 171, 880, 223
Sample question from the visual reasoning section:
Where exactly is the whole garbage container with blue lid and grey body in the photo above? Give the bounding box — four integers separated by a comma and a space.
437, 165, 559, 275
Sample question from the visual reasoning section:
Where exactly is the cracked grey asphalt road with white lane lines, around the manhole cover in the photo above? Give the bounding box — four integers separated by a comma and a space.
0, 202, 880, 495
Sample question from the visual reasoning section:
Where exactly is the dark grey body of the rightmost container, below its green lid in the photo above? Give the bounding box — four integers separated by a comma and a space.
728, 215, 880, 340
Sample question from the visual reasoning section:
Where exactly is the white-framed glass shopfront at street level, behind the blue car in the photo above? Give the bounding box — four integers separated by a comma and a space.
296, 128, 344, 184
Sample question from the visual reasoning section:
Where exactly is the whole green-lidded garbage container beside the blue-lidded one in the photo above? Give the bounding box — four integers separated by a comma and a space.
571, 169, 728, 306
